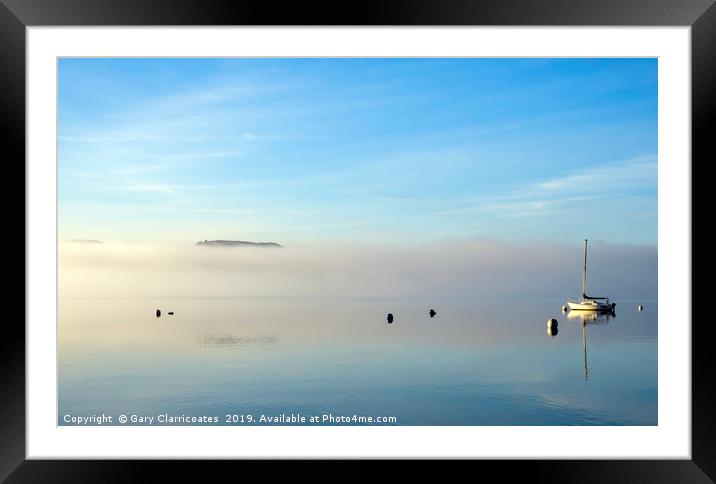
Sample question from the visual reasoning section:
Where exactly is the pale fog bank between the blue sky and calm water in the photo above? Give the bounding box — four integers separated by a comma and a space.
59, 240, 657, 300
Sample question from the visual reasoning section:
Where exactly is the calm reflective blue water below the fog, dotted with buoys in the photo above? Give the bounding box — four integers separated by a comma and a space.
58, 299, 658, 425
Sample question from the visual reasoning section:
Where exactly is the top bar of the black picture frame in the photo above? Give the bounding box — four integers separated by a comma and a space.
1, 0, 713, 26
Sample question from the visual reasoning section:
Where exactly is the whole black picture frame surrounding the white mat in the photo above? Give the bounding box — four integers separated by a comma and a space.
0, 0, 716, 482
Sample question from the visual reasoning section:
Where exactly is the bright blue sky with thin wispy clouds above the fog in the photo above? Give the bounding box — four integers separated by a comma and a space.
58, 59, 657, 246
